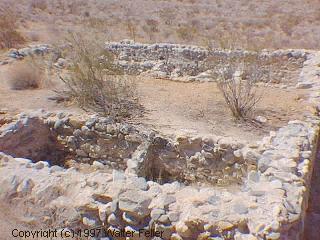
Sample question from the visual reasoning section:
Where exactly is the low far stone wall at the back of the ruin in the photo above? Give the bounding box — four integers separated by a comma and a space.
106, 41, 309, 86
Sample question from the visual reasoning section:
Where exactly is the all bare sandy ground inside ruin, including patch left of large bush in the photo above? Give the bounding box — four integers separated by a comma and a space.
0, 64, 306, 141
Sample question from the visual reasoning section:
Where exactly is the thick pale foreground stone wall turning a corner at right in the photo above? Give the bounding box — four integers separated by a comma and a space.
0, 117, 319, 240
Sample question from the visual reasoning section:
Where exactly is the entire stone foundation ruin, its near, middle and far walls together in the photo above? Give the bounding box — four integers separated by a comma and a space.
0, 42, 320, 240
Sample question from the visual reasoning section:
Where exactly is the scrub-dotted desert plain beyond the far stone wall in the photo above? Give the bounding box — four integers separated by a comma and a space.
1, 0, 320, 49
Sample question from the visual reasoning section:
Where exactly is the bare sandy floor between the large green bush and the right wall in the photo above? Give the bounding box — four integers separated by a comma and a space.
138, 79, 306, 141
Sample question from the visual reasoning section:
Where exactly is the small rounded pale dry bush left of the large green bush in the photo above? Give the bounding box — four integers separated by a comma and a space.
8, 60, 44, 90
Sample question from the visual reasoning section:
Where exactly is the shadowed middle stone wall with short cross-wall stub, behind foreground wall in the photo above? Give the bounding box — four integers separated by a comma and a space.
0, 112, 249, 185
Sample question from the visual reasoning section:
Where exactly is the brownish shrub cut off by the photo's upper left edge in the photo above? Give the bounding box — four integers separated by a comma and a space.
0, 7, 25, 49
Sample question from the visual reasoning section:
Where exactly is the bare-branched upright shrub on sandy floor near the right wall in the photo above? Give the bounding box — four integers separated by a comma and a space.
217, 57, 264, 120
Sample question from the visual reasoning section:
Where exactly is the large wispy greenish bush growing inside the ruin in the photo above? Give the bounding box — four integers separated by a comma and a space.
60, 34, 137, 119
